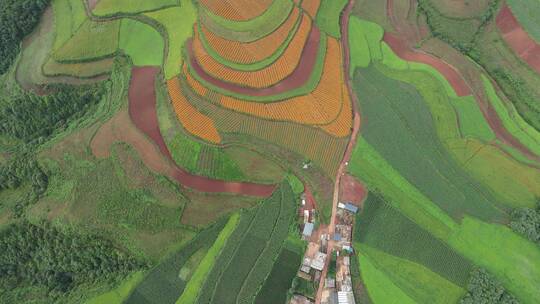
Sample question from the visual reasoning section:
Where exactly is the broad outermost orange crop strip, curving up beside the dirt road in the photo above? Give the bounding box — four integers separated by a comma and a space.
221, 37, 351, 129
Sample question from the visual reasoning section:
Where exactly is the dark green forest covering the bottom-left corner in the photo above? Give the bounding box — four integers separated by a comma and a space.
0, 222, 144, 303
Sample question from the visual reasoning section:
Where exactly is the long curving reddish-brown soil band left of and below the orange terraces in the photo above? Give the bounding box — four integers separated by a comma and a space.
129, 67, 275, 197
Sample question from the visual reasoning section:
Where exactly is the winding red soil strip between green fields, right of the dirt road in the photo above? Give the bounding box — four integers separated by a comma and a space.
383, 32, 472, 96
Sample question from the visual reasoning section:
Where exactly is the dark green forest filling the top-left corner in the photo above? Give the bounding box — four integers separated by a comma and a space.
0, 0, 50, 74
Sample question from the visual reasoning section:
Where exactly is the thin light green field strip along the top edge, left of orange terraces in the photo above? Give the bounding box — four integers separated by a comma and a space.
92, 0, 180, 17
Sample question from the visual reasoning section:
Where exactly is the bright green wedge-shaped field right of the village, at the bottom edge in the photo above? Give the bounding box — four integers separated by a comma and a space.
355, 243, 465, 304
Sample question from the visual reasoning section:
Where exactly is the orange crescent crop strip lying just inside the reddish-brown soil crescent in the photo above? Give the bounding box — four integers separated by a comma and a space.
193, 15, 312, 89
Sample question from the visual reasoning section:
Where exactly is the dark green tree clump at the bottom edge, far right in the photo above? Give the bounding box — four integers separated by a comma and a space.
460, 269, 519, 304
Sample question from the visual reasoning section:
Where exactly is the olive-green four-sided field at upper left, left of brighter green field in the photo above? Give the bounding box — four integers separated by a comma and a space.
53, 20, 120, 63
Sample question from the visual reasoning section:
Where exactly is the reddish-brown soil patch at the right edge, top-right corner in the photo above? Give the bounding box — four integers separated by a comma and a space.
496, 5, 540, 73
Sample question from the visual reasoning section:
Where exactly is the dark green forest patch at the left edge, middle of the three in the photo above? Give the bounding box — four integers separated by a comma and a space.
0, 84, 106, 143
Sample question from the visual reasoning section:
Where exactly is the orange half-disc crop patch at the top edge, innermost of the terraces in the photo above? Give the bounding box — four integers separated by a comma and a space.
199, 0, 273, 21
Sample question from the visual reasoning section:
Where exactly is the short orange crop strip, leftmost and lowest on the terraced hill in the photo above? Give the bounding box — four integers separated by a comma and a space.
167, 77, 221, 143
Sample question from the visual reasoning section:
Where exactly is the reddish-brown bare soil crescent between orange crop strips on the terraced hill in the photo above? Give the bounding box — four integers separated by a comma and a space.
187, 25, 321, 96
